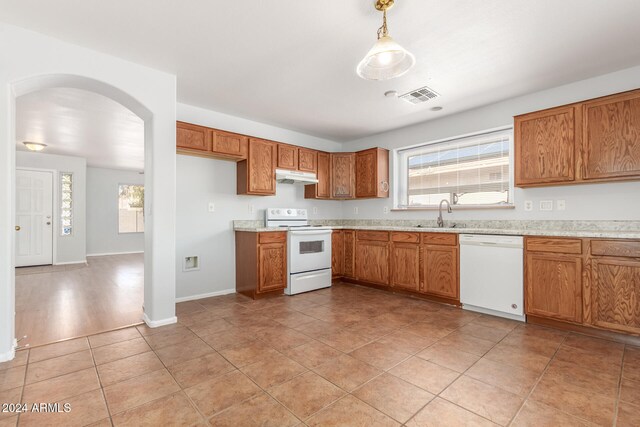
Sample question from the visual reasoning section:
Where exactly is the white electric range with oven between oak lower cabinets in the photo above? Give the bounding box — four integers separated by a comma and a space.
265, 208, 331, 295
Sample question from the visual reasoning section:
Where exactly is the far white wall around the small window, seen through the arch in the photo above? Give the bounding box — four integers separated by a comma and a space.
87, 167, 144, 256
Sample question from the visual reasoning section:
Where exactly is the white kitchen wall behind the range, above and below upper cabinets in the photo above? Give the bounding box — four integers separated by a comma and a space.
176, 104, 342, 298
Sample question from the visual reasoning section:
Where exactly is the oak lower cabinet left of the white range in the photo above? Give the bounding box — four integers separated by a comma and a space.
236, 231, 287, 298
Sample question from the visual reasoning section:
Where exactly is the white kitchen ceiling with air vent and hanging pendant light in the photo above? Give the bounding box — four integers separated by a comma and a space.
0, 0, 640, 141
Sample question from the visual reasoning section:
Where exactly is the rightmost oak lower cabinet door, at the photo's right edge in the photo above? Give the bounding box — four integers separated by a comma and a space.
590, 257, 640, 334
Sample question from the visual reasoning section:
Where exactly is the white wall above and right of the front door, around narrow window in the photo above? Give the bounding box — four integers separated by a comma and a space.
16, 151, 87, 264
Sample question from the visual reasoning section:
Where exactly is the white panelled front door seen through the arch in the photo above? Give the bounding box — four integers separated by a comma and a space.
16, 169, 53, 267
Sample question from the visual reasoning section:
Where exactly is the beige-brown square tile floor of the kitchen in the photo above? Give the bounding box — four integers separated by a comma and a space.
0, 285, 640, 427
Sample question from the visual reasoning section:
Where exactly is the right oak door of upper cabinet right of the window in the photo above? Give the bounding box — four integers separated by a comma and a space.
583, 91, 640, 179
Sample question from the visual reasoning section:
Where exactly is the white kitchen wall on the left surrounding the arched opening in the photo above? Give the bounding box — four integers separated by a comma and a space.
0, 24, 176, 360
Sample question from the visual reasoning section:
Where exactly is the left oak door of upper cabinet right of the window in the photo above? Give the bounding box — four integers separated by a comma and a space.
514, 106, 576, 186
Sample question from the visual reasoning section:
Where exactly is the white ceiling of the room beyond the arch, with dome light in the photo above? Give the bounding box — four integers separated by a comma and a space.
16, 88, 144, 171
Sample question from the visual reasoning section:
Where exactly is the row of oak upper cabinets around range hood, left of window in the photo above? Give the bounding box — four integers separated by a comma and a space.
176, 122, 389, 200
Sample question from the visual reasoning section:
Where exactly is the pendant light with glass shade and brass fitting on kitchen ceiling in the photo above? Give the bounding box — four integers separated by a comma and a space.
356, 0, 416, 80
